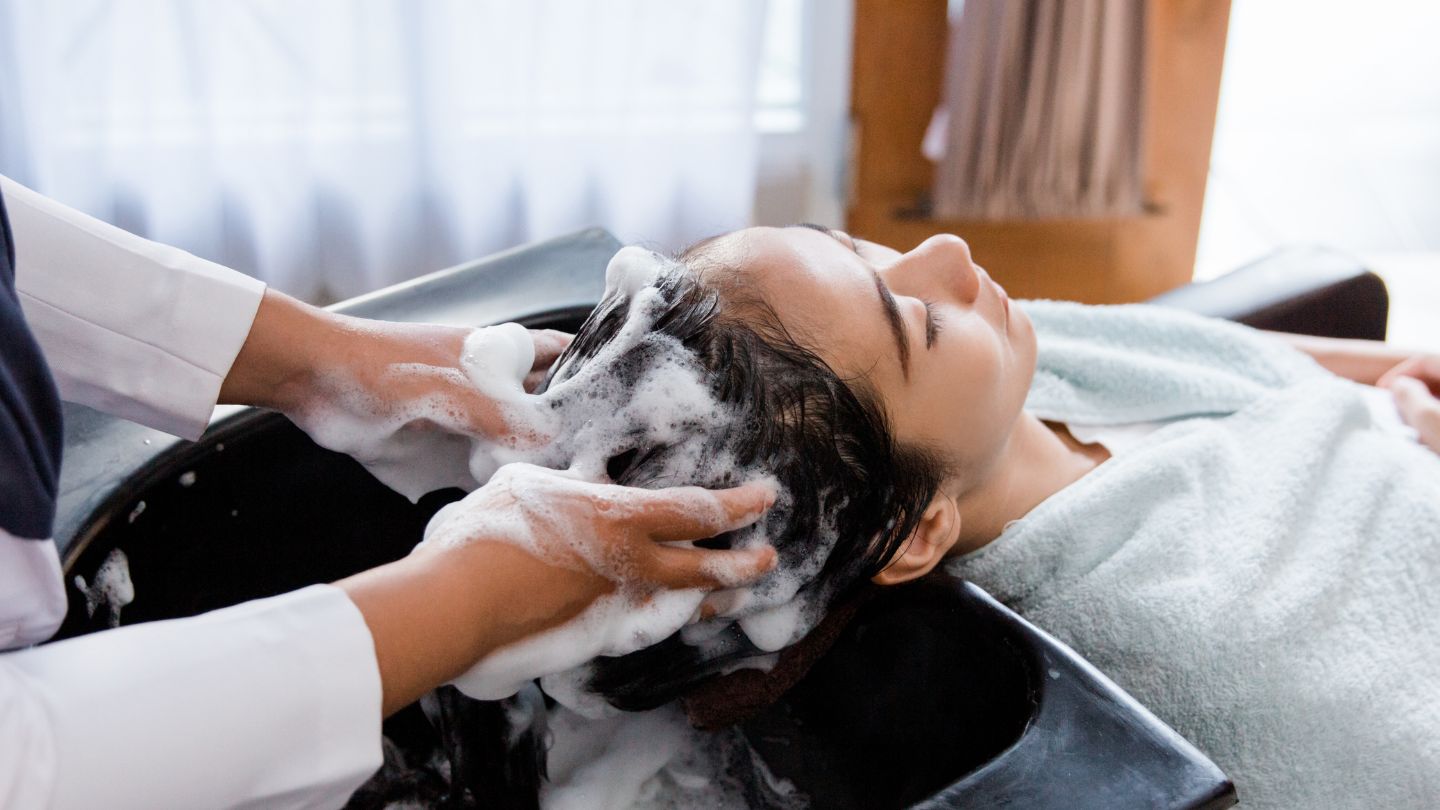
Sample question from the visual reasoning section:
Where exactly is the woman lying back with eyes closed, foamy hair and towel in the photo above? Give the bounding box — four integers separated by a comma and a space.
345, 228, 1440, 807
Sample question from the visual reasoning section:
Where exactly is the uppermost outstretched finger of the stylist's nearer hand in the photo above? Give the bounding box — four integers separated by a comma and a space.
636, 481, 775, 542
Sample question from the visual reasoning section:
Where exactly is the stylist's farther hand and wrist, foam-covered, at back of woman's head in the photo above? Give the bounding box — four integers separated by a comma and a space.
220, 290, 570, 499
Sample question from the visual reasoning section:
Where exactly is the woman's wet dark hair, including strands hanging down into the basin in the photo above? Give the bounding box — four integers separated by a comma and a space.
347, 244, 948, 810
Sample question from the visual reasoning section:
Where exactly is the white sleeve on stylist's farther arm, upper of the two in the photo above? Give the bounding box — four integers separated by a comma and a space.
0, 177, 265, 438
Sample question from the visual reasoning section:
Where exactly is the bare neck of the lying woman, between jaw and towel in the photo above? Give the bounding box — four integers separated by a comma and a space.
950, 411, 1110, 553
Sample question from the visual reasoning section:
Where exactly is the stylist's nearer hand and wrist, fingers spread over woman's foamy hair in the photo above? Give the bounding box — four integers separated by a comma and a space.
338, 464, 775, 713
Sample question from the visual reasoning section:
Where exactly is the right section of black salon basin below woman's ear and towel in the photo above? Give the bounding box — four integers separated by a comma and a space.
744, 572, 1236, 810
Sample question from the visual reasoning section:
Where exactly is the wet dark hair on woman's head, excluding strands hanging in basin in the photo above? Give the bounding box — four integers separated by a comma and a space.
546, 244, 948, 711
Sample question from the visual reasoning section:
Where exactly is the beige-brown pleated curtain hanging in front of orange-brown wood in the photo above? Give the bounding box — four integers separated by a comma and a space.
926, 0, 1145, 219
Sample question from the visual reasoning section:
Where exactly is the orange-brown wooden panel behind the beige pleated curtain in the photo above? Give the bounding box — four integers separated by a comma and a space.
847, 0, 1230, 303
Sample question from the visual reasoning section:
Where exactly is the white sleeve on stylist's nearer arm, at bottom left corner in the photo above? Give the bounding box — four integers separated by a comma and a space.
0, 585, 382, 810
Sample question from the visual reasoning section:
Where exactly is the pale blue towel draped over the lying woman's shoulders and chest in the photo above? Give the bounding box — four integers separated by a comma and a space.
949, 303, 1440, 809
